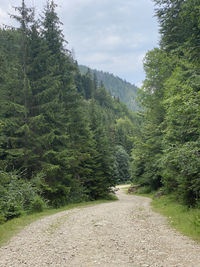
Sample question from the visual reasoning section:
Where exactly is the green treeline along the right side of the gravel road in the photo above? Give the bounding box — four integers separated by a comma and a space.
132, 0, 200, 207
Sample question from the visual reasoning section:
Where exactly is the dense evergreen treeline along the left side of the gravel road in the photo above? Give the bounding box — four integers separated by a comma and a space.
0, 1, 135, 222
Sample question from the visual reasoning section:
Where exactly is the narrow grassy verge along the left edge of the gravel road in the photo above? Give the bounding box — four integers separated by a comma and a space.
0, 197, 116, 247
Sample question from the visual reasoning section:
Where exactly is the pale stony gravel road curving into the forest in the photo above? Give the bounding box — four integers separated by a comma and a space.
0, 186, 200, 267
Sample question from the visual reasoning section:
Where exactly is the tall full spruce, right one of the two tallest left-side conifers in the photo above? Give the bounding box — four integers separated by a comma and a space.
36, 1, 84, 205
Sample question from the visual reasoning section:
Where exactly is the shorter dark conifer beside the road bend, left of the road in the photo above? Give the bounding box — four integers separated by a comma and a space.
88, 100, 117, 199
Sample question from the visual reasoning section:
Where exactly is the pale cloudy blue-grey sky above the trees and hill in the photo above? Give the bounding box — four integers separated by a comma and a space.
0, 0, 159, 86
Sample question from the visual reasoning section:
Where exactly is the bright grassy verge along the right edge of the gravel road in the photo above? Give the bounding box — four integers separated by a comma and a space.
126, 187, 200, 242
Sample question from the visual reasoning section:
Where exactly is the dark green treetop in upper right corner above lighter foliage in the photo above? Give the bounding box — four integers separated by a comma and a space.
154, 0, 200, 64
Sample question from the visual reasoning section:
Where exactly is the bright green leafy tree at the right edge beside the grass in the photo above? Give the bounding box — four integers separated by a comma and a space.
162, 61, 200, 205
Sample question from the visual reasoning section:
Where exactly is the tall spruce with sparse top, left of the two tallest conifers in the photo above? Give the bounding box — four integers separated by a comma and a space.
0, 1, 33, 173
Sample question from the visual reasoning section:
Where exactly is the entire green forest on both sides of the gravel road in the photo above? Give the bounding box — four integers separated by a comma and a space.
0, 0, 200, 226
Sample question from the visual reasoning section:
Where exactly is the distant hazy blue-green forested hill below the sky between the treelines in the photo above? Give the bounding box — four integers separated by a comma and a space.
79, 65, 138, 111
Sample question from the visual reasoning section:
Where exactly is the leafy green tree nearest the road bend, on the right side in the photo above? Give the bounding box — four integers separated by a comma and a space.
132, 48, 173, 189
